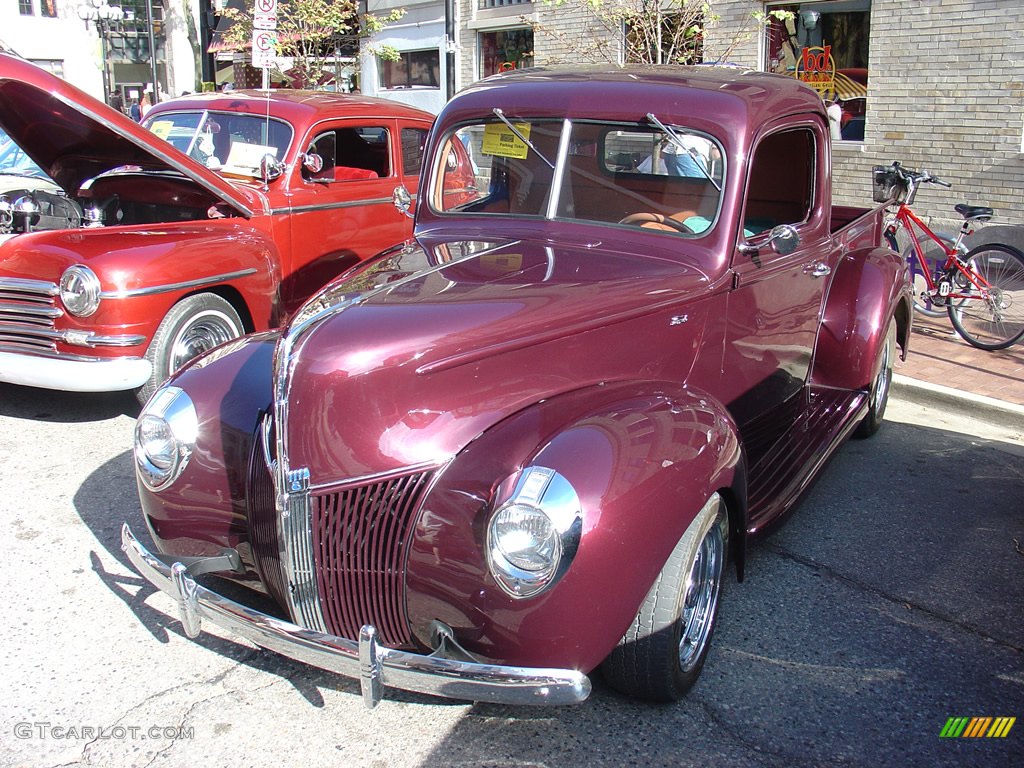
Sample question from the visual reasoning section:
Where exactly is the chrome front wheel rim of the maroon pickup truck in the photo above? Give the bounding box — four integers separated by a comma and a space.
679, 521, 725, 673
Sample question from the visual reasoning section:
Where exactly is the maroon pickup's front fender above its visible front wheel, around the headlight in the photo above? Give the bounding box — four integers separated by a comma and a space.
407, 383, 745, 671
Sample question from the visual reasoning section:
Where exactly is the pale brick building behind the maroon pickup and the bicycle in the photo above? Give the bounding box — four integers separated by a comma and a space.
442, 0, 1024, 229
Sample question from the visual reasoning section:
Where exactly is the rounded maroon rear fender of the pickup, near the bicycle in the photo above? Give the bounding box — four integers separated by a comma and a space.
811, 248, 912, 389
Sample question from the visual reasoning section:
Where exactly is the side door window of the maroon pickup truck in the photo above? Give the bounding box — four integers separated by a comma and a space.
743, 128, 815, 237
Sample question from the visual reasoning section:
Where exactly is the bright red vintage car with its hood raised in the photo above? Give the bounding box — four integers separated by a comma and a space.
0, 55, 433, 400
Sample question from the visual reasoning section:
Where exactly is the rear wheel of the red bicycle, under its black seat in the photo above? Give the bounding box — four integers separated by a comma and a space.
949, 243, 1024, 349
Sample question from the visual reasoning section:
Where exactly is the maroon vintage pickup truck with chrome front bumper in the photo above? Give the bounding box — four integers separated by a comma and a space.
123, 67, 910, 705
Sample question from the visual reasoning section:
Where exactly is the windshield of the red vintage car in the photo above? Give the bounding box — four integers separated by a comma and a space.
144, 111, 292, 177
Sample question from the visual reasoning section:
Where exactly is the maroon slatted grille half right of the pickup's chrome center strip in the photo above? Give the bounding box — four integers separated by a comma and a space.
311, 472, 430, 647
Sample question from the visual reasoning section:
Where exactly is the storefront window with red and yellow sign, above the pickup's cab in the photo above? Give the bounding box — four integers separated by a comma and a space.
764, 0, 871, 141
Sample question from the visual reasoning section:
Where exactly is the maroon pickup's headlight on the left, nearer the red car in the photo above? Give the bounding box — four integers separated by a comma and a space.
135, 387, 199, 490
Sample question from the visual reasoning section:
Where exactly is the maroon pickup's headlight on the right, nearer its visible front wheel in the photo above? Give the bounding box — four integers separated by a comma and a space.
487, 467, 583, 597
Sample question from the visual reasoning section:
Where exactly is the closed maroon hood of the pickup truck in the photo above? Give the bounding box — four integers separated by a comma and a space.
275, 234, 716, 484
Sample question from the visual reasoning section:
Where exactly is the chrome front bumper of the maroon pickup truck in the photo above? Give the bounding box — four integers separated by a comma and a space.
121, 524, 591, 708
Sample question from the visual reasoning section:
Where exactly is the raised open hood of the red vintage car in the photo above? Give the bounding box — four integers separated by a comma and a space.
0, 54, 253, 218
